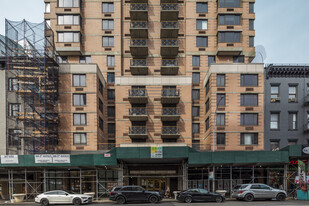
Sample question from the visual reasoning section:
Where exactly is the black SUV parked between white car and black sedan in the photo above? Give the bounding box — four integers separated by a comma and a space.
109, 186, 162, 204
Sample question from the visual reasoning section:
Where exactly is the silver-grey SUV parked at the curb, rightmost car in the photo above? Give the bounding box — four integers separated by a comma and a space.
232, 183, 287, 202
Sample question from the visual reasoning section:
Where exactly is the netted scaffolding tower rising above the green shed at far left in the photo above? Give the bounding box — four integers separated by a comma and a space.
5, 19, 59, 154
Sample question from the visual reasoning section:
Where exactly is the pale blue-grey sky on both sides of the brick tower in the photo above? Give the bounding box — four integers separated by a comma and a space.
0, 0, 309, 64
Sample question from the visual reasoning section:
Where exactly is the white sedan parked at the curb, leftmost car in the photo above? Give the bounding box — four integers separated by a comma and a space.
35, 190, 92, 206
